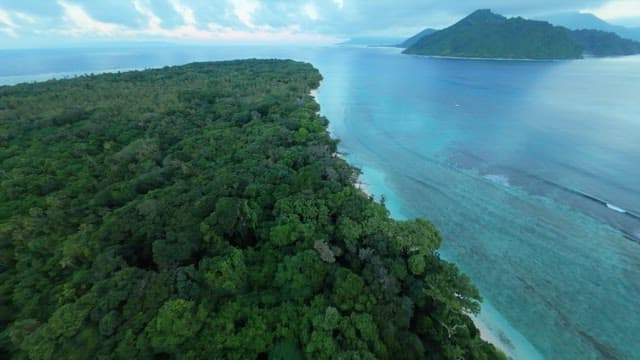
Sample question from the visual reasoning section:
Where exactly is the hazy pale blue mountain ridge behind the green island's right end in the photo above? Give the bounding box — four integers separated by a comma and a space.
537, 12, 640, 41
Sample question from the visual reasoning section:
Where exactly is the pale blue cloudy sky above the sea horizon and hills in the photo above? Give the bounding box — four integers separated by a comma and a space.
0, 0, 640, 48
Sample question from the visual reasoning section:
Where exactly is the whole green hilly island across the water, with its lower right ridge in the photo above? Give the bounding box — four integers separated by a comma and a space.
404, 9, 640, 60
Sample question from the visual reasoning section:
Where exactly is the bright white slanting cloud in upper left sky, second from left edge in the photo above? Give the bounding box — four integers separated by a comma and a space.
58, 0, 127, 36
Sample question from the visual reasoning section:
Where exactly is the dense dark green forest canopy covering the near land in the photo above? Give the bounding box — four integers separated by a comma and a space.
0, 60, 504, 359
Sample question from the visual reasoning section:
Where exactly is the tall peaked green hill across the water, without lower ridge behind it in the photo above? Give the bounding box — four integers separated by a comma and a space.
404, 10, 582, 59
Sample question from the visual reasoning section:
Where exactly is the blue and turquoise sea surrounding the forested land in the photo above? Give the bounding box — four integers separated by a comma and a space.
0, 47, 640, 359
